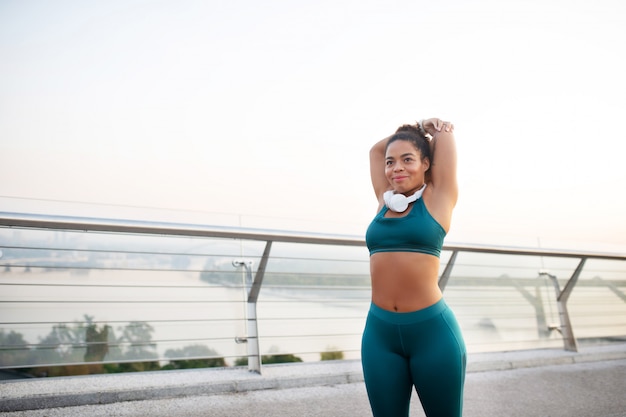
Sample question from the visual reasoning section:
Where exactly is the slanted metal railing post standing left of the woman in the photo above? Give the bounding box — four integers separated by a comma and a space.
233, 241, 272, 374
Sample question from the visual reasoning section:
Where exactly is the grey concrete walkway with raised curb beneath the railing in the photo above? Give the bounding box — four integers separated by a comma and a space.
0, 344, 626, 417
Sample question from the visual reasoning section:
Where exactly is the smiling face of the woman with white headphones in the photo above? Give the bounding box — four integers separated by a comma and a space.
385, 140, 430, 194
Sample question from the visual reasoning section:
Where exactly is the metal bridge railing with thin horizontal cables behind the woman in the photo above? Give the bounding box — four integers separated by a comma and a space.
0, 212, 626, 373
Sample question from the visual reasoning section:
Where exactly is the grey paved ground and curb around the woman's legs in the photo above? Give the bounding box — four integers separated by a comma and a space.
0, 345, 626, 417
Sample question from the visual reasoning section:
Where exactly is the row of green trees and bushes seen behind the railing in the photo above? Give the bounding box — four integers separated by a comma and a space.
0, 315, 316, 376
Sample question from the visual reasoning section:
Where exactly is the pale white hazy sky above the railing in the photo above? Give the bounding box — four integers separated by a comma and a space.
0, 0, 626, 250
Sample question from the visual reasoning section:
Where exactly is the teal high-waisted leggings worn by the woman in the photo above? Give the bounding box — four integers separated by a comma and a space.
361, 299, 466, 417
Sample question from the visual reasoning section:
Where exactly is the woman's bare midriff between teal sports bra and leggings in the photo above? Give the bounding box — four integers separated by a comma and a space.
370, 252, 442, 313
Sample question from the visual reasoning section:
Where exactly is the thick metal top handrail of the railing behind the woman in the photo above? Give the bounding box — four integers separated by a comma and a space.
0, 212, 626, 261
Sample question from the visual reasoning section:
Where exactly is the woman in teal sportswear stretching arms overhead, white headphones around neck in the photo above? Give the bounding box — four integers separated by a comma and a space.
361, 119, 466, 417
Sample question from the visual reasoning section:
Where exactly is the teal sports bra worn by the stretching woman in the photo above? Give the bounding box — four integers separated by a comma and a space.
365, 198, 446, 257
